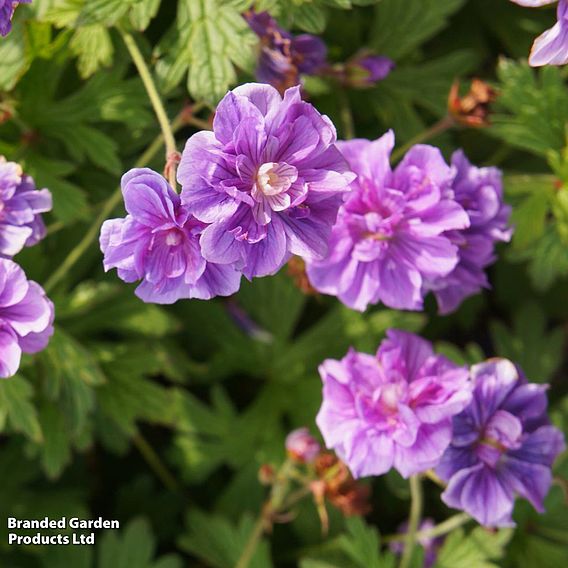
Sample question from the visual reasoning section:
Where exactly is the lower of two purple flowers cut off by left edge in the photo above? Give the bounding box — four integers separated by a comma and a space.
0, 258, 54, 379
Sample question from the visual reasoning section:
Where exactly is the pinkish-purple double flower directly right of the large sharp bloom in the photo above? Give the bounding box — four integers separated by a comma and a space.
307, 132, 469, 311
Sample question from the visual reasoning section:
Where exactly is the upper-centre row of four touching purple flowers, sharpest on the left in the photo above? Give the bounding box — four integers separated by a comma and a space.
100, 84, 511, 313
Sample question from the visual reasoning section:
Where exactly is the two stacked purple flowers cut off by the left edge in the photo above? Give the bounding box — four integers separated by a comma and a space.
0, 156, 54, 378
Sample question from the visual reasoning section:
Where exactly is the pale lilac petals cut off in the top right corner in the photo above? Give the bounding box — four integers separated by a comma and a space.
512, 0, 568, 67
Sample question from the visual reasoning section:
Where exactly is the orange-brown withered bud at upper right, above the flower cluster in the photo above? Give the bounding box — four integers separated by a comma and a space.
448, 79, 497, 128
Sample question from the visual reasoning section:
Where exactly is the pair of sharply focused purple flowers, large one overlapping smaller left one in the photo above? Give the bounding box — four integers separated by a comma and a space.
100, 84, 355, 303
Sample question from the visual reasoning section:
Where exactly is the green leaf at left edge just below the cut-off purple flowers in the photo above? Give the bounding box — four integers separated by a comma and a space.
0, 375, 42, 444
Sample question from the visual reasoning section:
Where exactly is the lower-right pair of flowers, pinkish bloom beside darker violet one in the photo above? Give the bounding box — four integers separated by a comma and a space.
317, 330, 565, 527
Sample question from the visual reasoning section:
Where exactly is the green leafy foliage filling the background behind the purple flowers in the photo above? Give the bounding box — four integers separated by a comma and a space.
0, 0, 568, 568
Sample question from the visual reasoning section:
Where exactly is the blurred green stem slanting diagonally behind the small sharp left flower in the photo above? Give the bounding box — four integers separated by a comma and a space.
44, 111, 185, 293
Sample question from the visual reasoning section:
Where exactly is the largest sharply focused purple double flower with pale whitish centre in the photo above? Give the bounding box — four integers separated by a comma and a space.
178, 83, 356, 279
